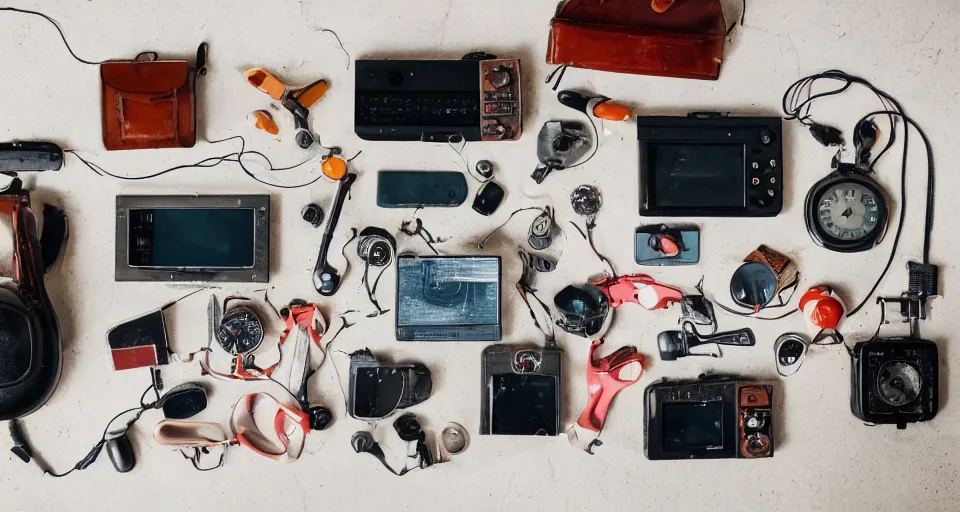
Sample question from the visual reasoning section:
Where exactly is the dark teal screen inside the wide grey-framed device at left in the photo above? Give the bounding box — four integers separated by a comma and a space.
130, 208, 255, 269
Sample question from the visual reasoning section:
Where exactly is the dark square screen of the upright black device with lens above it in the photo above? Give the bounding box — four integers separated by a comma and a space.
490, 373, 559, 436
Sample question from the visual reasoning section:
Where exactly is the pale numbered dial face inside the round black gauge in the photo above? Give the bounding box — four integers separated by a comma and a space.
817, 181, 883, 242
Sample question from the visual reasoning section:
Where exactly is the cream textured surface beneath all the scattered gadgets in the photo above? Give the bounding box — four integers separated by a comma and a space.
0, 0, 960, 512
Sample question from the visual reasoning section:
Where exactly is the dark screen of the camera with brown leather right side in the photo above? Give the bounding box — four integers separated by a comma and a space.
661, 401, 723, 453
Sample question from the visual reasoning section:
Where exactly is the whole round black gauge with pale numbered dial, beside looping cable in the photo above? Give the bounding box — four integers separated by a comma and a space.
807, 177, 887, 252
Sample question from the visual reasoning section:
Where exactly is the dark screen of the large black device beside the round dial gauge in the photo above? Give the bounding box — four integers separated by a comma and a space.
647, 143, 746, 208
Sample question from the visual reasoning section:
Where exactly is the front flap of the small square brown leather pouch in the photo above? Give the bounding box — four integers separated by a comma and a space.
100, 60, 190, 93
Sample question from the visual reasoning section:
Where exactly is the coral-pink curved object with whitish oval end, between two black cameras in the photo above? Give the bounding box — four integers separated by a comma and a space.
577, 339, 643, 432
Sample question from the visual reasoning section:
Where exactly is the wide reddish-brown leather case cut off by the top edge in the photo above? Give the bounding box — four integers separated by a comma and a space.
547, 0, 726, 80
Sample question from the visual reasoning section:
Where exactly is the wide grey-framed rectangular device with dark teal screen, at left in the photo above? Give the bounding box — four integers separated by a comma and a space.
114, 195, 270, 283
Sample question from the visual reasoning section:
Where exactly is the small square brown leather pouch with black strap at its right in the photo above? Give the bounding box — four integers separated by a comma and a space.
100, 43, 207, 150
